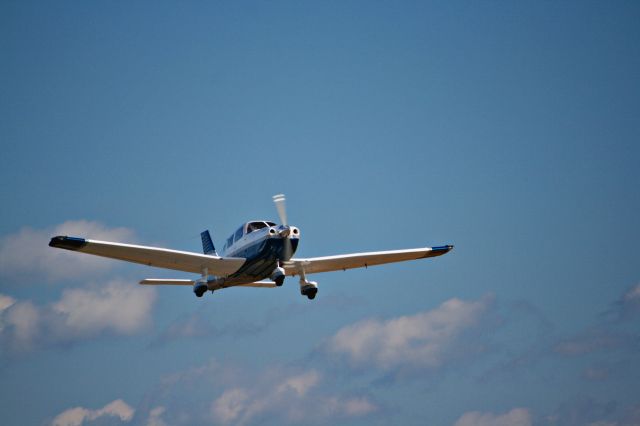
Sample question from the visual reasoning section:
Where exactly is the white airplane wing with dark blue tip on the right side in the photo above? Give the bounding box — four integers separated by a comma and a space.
283, 245, 453, 275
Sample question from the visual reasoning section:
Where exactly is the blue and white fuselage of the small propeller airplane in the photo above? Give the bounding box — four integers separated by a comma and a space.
215, 221, 300, 287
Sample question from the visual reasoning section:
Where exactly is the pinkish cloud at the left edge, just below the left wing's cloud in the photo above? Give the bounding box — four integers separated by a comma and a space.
0, 280, 156, 353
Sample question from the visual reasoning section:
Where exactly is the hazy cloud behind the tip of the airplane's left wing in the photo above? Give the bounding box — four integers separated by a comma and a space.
0, 220, 134, 284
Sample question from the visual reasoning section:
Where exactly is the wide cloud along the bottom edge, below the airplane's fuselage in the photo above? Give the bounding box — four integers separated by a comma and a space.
138, 360, 380, 425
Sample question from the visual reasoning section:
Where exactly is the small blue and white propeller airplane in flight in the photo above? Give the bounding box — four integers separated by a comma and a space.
49, 194, 453, 299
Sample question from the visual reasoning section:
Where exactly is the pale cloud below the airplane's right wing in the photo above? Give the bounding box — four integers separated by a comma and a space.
326, 296, 493, 370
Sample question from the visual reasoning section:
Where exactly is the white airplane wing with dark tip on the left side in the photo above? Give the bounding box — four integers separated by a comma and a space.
49, 236, 245, 276
